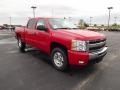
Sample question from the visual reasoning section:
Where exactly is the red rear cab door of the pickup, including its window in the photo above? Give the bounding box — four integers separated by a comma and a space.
25, 19, 35, 46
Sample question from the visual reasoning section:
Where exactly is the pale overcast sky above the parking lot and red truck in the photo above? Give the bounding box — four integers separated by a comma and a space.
0, 0, 120, 25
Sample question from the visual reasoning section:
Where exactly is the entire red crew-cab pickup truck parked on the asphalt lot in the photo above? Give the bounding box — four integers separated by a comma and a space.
15, 18, 107, 71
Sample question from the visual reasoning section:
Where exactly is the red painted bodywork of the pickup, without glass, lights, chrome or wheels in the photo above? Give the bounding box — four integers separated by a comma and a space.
15, 18, 106, 65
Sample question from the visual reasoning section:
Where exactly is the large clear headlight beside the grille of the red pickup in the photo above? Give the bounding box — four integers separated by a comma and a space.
71, 40, 87, 51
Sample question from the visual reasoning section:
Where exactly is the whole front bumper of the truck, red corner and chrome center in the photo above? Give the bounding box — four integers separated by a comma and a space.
68, 47, 107, 65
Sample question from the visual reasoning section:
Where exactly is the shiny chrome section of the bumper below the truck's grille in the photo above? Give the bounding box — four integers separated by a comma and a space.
89, 47, 107, 60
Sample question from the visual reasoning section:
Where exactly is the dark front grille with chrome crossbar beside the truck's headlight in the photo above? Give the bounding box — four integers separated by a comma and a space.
88, 39, 106, 52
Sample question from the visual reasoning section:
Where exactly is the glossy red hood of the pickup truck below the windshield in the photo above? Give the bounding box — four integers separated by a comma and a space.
55, 29, 106, 40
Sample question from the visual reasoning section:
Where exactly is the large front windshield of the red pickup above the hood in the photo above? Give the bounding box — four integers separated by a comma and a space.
49, 18, 78, 29
